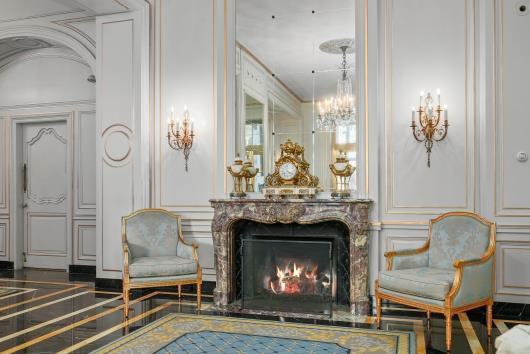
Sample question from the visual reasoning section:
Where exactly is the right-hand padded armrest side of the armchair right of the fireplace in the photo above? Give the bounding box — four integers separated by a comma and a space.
447, 253, 494, 307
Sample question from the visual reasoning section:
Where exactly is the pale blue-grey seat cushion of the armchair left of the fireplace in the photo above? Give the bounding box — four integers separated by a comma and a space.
129, 256, 197, 278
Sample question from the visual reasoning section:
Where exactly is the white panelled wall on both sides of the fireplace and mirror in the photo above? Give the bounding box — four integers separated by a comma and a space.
146, 0, 530, 302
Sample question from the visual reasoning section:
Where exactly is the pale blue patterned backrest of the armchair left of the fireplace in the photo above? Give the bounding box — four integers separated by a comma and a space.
122, 209, 180, 258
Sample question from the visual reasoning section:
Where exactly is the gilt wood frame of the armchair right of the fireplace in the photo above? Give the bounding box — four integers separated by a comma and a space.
375, 211, 495, 351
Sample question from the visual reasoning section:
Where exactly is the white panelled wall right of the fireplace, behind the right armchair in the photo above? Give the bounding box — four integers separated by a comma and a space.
370, 0, 530, 302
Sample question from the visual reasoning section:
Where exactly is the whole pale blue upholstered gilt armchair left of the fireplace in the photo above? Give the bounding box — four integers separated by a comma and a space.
122, 209, 202, 317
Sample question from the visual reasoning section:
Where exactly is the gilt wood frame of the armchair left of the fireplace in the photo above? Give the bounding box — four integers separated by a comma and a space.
121, 208, 202, 317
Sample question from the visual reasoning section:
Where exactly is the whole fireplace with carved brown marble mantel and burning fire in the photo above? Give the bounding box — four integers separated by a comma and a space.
210, 198, 371, 315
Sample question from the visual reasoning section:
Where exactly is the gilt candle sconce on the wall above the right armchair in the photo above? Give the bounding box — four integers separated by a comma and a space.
410, 89, 449, 167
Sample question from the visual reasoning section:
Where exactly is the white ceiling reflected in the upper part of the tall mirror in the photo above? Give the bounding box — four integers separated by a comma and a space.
236, 0, 355, 102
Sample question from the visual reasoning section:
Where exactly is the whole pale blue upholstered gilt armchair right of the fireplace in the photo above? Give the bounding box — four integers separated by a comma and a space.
375, 212, 495, 351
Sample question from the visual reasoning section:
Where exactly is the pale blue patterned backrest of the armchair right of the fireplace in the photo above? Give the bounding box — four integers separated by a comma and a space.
429, 212, 493, 269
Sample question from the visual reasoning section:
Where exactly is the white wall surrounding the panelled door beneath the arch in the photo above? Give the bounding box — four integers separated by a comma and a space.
0, 48, 96, 265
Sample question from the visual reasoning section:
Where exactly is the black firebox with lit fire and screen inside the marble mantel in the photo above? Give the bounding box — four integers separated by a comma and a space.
233, 220, 349, 315
